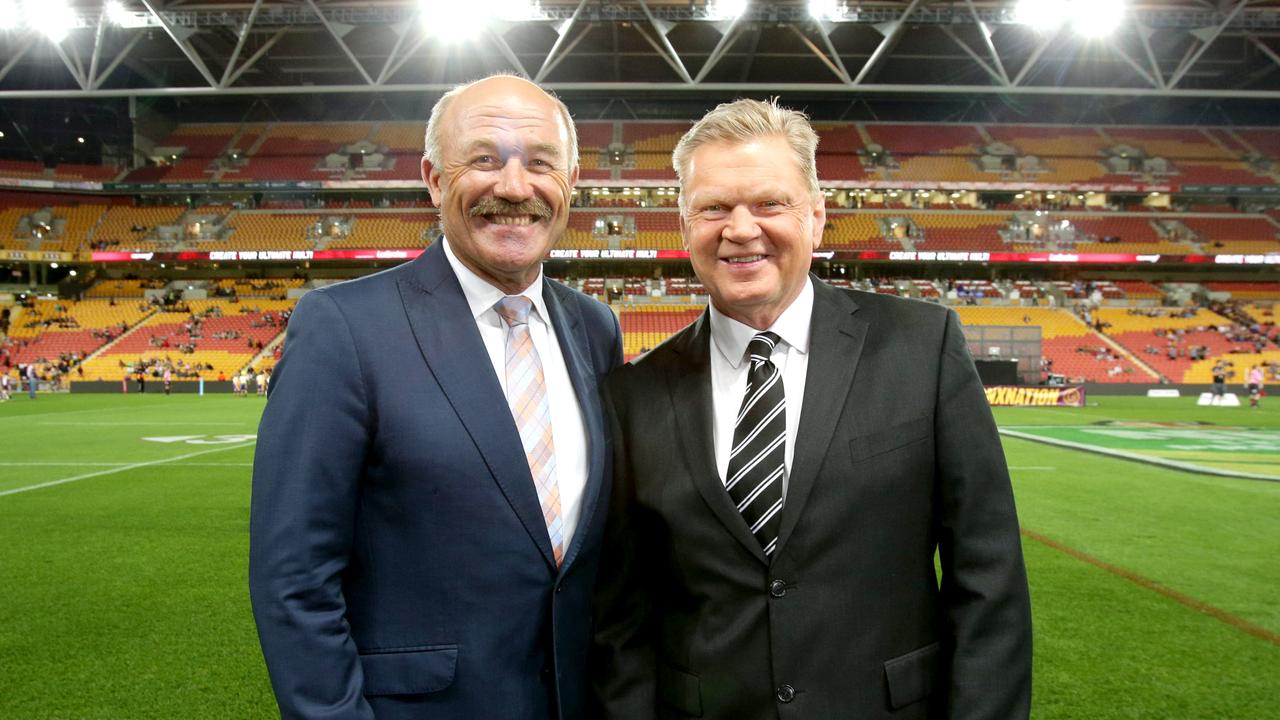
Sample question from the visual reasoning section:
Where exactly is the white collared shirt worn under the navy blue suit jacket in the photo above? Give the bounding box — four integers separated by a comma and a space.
440, 238, 588, 552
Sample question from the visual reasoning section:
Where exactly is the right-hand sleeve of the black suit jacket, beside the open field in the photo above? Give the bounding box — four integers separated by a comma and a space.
934, 310, 1032, 720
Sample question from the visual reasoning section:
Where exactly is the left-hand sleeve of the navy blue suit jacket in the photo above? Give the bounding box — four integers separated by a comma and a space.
248, 291, 372, 719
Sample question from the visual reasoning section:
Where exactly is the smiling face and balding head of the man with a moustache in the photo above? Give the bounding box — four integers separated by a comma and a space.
422, 77, 577, 295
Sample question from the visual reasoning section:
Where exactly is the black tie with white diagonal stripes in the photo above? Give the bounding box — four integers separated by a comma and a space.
724, 332, 787, 556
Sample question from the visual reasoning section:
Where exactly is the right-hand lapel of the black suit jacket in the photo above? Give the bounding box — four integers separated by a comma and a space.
773, 278, 868, 557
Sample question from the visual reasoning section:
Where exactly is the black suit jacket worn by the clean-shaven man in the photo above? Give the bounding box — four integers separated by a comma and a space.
593, 278, 1032, 720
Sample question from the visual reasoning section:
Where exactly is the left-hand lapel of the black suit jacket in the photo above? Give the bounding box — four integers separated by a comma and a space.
667, 311, 768, 562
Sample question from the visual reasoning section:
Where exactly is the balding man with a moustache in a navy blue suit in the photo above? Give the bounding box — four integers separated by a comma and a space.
250, 76, 621, 720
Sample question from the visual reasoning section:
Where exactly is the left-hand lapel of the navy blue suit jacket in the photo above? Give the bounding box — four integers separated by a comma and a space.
398, 242, 556, 569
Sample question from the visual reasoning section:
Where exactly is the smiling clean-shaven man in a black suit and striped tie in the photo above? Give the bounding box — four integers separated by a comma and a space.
593, 100, 1032, 720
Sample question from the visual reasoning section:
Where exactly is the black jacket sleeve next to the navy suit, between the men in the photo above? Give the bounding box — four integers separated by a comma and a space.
590, 376, 658, 720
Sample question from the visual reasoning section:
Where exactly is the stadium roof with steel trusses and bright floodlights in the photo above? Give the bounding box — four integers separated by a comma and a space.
0, 0, 1280, 100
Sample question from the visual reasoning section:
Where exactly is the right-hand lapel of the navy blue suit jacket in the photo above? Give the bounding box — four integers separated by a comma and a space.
543, 278, 604, 573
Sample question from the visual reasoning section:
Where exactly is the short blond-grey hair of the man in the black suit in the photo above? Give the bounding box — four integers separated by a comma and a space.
671, 97, 822, 208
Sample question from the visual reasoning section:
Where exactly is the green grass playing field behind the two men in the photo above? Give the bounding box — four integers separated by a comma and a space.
0, 395, 1280, 720
